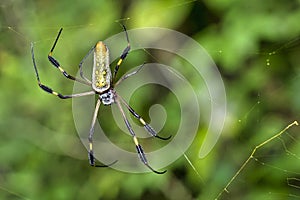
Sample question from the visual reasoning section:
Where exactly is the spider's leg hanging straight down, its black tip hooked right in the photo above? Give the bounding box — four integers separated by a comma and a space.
88, 98, 117, 167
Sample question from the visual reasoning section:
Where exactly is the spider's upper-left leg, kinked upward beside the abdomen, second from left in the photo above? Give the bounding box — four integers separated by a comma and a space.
48, 28, 91, 85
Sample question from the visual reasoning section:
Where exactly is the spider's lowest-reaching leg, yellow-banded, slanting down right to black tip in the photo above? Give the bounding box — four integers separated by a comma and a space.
116, 99, 166, 174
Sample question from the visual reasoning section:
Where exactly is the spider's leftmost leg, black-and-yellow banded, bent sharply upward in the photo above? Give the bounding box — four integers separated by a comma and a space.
31, 43, 95, 99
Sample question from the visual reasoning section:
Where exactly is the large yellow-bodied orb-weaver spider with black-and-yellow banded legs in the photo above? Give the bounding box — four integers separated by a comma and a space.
31, 25, 171, 174
